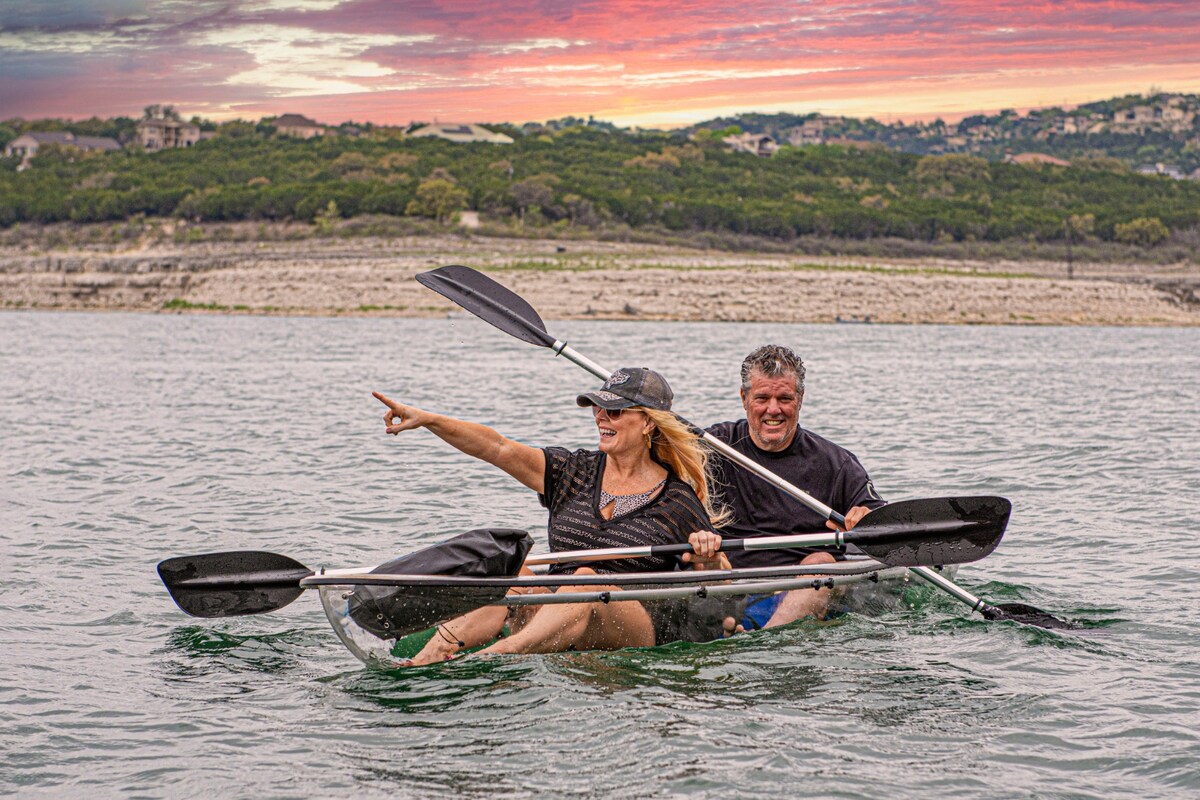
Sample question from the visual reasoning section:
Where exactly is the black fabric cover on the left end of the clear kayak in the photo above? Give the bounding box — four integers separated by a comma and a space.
347, 528, 533, 639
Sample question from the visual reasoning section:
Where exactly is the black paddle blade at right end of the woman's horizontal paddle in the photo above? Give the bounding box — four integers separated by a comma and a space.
846, 497, 1013, 566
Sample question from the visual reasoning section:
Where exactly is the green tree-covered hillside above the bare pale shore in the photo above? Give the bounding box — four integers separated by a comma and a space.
0, 120, 1200, 246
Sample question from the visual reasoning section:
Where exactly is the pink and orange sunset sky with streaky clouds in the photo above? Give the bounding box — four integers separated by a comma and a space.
0, 0, 1200, 127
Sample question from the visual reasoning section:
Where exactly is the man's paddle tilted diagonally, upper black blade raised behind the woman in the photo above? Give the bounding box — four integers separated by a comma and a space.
416, 265, 1069, 627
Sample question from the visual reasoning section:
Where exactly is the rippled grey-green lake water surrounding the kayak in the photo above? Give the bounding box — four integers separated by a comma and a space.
0, 313, 1200, 798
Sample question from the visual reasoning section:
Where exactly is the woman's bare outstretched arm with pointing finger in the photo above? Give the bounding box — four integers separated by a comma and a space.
372, 392, 546, 492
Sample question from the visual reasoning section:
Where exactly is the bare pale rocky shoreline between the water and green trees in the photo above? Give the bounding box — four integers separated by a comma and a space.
0, 236, 1200, 326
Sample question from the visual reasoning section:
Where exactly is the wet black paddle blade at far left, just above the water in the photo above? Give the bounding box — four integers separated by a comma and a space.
158, 552, 312, 618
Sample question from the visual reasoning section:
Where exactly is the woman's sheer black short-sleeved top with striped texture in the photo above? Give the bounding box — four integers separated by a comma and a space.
539, 447, 713, 572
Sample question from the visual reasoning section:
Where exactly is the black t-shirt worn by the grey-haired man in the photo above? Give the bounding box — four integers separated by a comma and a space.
708, 420, 884, 567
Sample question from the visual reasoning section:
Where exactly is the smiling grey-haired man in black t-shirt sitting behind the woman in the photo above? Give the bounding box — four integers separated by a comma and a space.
689, 344, 884, 628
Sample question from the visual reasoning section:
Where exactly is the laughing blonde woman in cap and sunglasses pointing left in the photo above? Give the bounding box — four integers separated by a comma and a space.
374, 367, 727, 664
